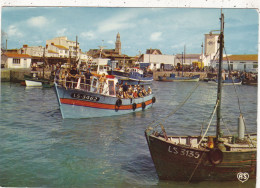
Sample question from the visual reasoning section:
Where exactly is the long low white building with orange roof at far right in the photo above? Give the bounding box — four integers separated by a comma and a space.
212, 54, 258, 72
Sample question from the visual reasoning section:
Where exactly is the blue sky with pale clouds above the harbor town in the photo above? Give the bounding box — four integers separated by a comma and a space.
1, 7, 259, 56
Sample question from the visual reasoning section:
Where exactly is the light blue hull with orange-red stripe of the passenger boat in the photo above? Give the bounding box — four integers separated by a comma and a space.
55, 84, 155, 118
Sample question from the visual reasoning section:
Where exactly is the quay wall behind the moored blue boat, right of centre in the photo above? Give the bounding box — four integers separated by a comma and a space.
153, 71, 207, 80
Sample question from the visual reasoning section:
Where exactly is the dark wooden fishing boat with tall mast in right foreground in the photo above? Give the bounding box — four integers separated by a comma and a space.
145, 13, 257, 182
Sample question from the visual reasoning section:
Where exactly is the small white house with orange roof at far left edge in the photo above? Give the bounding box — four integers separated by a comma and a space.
1, 53, 32, 68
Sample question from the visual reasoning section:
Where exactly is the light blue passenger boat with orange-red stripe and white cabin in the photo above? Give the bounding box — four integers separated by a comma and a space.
55, 71, 156, 118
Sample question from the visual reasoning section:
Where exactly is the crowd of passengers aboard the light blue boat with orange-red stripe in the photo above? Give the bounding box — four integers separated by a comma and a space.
57, 67, 152, 99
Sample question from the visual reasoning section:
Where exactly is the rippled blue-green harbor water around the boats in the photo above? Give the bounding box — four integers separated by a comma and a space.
0, 81, 257, 188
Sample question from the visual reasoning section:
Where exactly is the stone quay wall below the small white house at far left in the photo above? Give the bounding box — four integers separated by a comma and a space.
1, 69, 51, 83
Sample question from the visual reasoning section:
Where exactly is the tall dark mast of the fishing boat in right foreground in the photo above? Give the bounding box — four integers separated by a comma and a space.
216, 11, 224, 142
